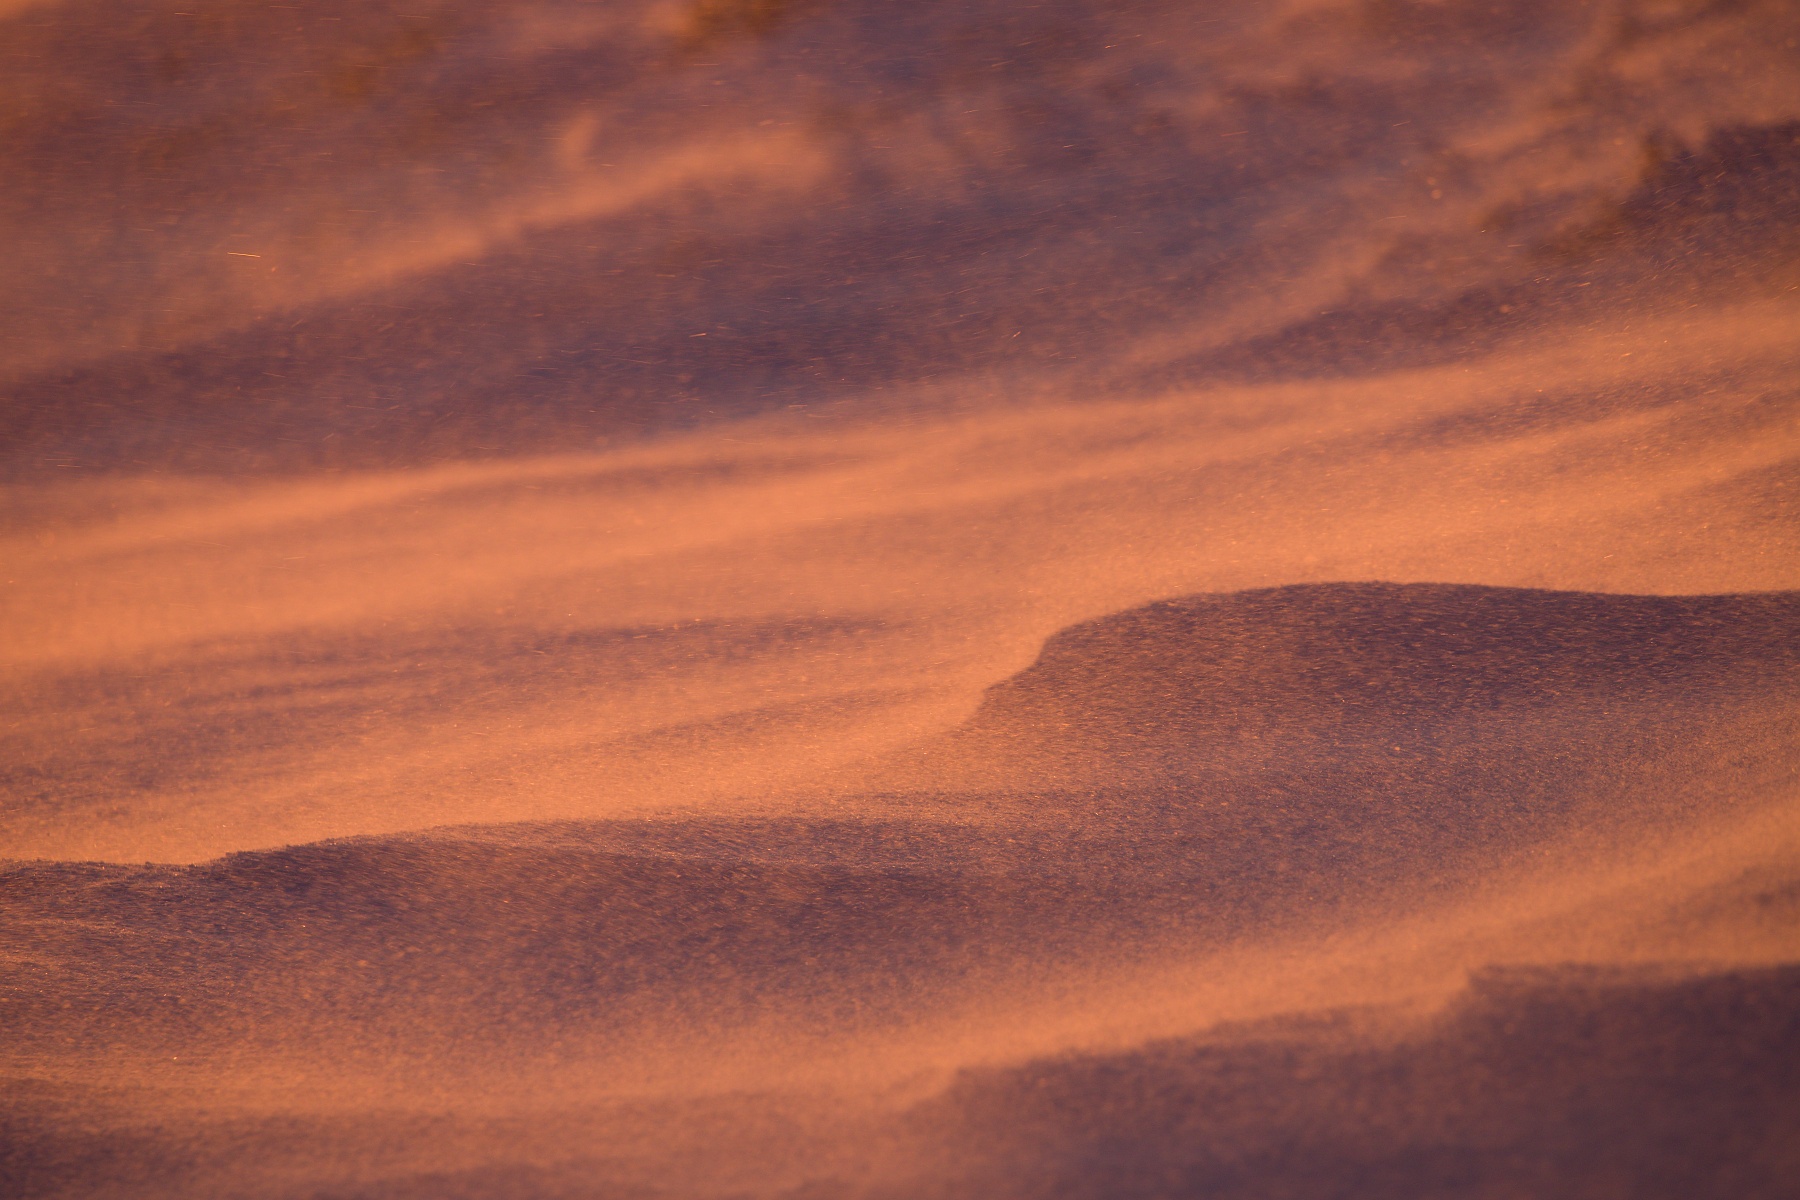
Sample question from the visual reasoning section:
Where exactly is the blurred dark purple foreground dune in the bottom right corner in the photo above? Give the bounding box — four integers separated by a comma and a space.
878, 968, 1800, 1200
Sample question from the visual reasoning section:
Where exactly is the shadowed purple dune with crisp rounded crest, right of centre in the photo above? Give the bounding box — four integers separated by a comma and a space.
864, 583, 1800, 916
